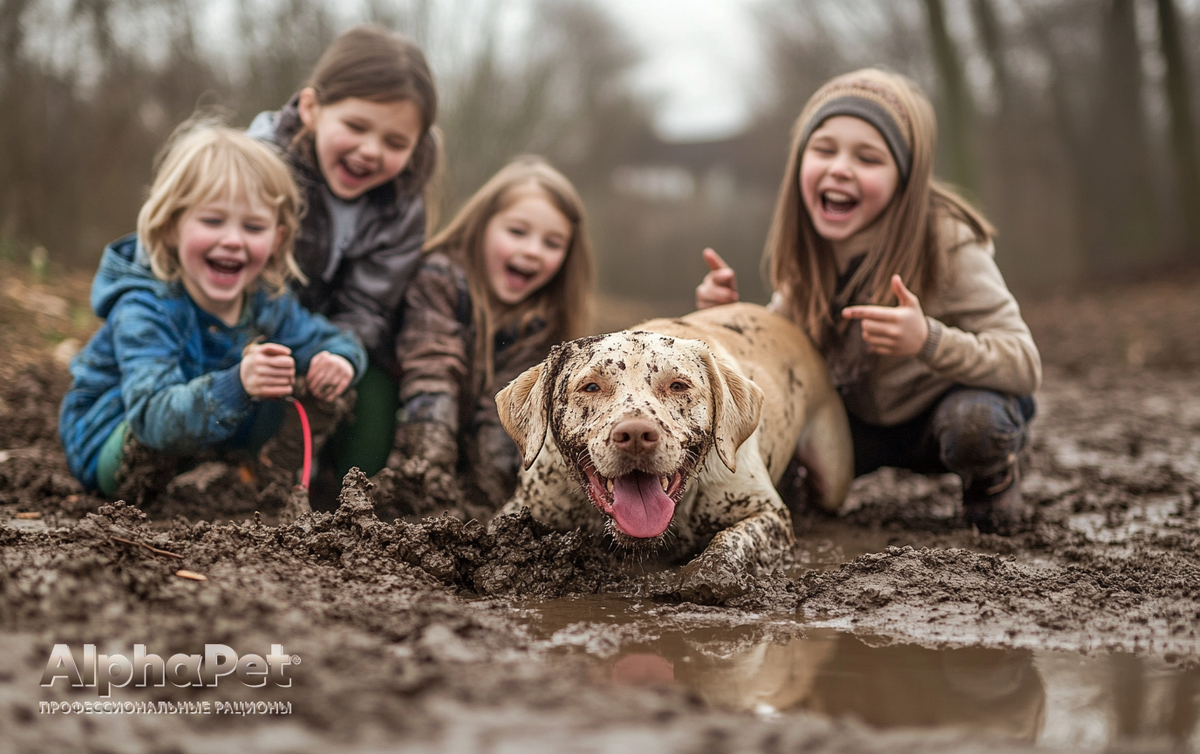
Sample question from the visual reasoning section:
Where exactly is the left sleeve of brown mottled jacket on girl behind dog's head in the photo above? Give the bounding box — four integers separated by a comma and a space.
396, 252, 474, 430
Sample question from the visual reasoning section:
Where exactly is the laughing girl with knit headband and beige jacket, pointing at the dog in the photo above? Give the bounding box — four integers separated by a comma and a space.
696, 68, 1042, 531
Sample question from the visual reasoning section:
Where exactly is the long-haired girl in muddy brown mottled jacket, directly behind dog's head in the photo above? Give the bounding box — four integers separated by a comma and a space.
379, 157, 593, 513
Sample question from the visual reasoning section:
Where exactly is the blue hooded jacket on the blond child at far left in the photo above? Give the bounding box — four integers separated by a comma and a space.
59, 234, 366, 489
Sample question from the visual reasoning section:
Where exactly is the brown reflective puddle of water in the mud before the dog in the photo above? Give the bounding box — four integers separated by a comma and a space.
523, 597, 1200, 752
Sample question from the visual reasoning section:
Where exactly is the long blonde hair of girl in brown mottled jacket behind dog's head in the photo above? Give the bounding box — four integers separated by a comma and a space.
425, 156, 595, 384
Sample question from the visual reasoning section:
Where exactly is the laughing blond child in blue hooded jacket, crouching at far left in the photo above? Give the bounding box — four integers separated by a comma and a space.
59, 124, 366, 503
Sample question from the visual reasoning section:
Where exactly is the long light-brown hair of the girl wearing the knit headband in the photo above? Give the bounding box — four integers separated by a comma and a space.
763, 68, 995, 347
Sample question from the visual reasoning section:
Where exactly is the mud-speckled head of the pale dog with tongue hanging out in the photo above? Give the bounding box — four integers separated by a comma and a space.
496, 331, 762, 544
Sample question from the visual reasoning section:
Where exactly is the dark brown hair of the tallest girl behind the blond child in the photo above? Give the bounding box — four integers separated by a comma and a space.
296, 24, 442, 218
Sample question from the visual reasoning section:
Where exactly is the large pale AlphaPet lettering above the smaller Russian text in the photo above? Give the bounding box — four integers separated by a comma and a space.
42, 644, 300, 699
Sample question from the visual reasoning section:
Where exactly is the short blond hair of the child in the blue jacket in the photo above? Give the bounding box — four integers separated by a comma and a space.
138, 118, 306, 295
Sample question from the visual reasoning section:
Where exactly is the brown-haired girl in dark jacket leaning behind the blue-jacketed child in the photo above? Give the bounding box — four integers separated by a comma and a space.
248, 26, 439, 479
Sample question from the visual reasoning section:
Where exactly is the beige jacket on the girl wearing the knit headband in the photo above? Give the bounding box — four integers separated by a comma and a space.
772, 221, 1042, 425
